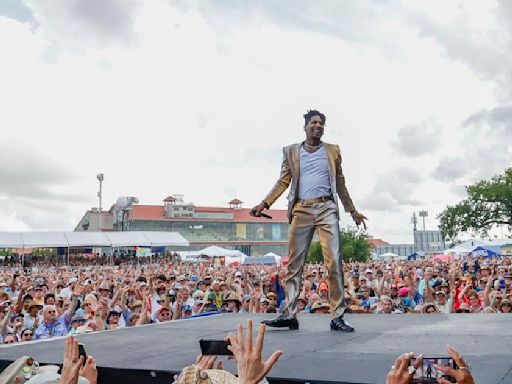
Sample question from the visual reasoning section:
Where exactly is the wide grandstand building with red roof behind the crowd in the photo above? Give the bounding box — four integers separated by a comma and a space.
75, 195, 289, 256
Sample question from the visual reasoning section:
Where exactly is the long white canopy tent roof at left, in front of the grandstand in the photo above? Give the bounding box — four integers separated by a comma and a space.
0, 231, 190, 249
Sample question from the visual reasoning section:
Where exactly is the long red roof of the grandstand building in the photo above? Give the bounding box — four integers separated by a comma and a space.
129, 205, 288, 223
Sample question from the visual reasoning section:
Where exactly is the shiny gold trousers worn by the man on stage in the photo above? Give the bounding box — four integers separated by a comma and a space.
284, 201, 345, 317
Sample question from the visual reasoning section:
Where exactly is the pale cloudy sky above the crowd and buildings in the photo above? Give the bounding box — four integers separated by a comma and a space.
0, 0, 512, 242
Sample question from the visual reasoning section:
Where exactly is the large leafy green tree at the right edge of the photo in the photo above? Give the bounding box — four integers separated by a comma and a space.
437, 168, 512, 241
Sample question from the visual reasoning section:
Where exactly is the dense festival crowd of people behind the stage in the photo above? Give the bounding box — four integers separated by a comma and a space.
0, 257, 512, 344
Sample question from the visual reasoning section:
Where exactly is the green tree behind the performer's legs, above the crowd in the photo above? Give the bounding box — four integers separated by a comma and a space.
306, 232, 371, 263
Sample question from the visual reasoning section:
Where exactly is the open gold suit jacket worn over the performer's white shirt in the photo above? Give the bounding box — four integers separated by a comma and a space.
264, 142, 355, 222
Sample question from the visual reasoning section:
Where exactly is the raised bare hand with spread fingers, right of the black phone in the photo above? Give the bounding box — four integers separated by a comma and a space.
226, 320, 283, 384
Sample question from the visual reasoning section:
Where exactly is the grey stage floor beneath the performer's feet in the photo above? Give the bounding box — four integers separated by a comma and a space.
0, 314, 512, 384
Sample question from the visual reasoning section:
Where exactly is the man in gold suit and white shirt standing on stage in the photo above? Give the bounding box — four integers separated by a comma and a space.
251, 110, 366, 332
